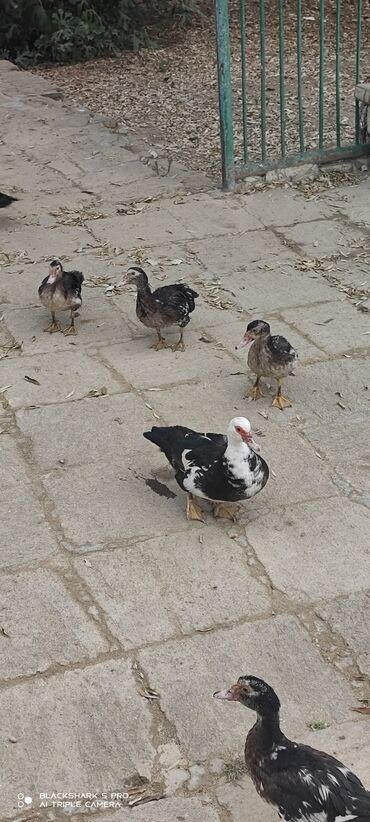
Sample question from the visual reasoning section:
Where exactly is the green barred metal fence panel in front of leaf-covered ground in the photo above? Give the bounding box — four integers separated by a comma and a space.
215, 0, 369, 189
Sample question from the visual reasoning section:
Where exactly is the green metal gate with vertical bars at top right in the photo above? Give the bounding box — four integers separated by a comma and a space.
215, 0, 369, 189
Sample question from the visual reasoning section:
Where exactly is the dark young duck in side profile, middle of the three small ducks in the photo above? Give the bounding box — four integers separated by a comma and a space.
120, 265, 199, 351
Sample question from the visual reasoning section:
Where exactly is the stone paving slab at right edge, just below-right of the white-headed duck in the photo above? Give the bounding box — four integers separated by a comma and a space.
247, 495, 370, 602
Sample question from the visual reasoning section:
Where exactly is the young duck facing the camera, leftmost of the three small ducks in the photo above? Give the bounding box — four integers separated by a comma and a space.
39, 259, 84, 336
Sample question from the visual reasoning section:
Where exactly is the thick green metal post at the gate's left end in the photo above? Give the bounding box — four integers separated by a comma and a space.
215, 0, 235, 190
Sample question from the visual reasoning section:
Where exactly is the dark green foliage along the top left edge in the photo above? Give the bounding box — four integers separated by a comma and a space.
0, 0, 204, 66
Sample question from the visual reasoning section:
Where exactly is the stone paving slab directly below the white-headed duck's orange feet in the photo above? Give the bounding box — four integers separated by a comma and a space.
75, 525, 271, 648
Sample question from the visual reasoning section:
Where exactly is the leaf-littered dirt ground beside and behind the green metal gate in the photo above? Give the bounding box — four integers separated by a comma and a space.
37, 0, 370, 176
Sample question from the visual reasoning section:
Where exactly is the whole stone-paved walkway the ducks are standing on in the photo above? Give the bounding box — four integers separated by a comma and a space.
0, 63, 370, 822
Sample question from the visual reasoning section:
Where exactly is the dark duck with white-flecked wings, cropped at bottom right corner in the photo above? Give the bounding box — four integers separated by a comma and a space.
214, 676, 370, 822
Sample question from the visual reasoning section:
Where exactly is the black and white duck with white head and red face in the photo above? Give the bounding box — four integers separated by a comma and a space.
144, 417, 269, 522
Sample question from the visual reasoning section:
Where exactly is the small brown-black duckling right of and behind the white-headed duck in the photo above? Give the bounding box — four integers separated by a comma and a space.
236, 320, 298, 410
